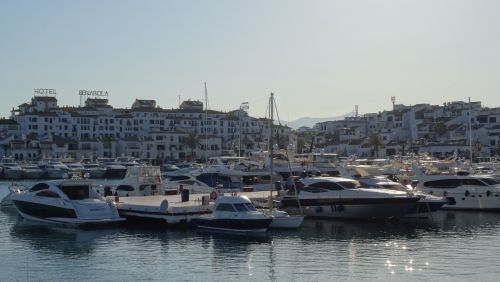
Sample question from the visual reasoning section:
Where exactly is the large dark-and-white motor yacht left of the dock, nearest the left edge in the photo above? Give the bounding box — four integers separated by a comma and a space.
10, 179, 125, 227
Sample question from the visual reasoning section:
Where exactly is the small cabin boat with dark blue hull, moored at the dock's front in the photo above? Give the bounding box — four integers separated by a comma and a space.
192, 196, 272, 233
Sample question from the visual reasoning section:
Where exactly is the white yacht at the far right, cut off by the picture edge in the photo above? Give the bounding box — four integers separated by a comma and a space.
415, 175, 500, 211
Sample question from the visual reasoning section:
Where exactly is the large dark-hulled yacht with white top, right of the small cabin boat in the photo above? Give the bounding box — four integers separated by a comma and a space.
281, 177, 419, 219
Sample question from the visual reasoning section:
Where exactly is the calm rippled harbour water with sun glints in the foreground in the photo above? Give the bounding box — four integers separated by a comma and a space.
0, 183, 500, 281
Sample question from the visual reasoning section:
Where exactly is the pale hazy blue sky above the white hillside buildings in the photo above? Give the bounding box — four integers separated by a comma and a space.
0, 0, 500, 121
